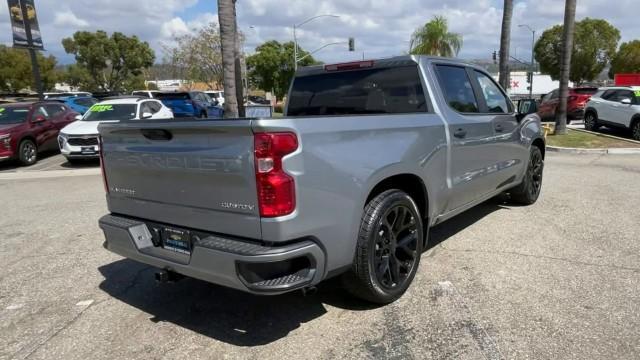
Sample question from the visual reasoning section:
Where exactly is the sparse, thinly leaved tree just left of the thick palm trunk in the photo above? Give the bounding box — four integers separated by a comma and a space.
164, 22, 222, 90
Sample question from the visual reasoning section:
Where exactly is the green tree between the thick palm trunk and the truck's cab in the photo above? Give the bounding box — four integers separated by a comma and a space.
245, 40, 317, 99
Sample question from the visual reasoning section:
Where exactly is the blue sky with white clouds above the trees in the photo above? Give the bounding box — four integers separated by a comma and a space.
0, 0, 640, 63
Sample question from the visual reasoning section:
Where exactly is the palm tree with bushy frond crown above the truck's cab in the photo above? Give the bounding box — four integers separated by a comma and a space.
410, 16, 462, 57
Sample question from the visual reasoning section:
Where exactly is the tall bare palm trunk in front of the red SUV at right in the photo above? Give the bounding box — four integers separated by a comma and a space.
556, 0, 576, 135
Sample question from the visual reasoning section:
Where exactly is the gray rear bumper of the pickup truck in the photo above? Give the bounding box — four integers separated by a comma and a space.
100, 215, 325, 295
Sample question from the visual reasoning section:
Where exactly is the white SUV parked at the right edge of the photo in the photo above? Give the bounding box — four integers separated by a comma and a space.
584, 86, 640, 140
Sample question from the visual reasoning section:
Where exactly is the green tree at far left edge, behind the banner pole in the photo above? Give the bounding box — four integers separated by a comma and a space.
0, 45, 58, 92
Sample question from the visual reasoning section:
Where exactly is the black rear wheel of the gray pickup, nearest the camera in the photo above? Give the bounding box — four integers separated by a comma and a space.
342, 189, 425, 304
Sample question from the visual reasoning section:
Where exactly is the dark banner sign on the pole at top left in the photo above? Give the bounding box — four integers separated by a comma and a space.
7, 0, 44, 50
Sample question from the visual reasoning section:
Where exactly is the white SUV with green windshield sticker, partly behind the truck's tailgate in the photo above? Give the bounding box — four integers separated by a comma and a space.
58, 97, 173, 162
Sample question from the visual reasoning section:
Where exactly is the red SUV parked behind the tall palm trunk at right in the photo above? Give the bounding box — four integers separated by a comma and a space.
538, 87, 598, 123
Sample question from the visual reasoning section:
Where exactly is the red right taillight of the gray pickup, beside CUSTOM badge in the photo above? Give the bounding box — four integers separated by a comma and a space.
253, 132, 298, 217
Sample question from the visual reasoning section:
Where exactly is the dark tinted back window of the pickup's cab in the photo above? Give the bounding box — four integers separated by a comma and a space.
287, 65, 427, 116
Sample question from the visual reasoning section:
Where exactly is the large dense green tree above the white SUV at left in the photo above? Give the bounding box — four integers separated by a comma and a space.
62, 30, 155, 91
